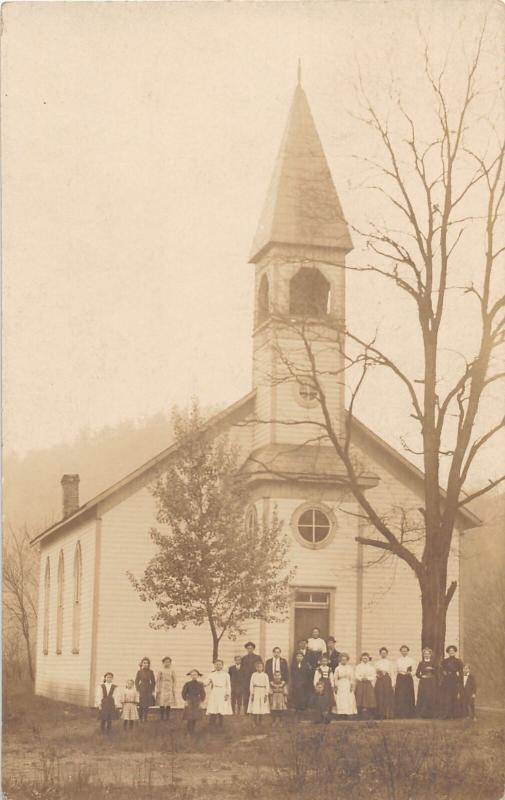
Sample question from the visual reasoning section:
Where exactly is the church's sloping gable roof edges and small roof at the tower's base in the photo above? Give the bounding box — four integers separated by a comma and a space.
32, 390, 482, 544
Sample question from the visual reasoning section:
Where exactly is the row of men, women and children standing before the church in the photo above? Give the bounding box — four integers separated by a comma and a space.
96, 628, 477, 734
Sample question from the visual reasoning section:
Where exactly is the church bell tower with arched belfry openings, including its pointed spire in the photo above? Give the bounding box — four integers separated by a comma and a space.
250, 76, 353, 448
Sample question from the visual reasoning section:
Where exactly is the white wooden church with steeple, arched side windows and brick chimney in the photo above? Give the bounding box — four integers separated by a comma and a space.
35, 79, 479, 705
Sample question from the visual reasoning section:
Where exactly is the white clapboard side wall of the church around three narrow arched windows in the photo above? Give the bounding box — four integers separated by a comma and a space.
35, 520, 96, 705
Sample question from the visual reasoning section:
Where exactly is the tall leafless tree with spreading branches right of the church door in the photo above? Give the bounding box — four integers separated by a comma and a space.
252, 35, 505, 655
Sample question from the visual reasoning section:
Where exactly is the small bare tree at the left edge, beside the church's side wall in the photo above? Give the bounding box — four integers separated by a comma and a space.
3, 528, 38, 681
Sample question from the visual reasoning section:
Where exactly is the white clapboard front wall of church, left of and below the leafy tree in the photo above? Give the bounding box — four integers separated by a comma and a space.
96, 488, 259, 705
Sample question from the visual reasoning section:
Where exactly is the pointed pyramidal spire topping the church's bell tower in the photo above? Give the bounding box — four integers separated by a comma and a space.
250, 83, 352, 261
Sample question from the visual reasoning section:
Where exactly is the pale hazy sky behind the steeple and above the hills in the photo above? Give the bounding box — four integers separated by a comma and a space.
2, 0, 504, 482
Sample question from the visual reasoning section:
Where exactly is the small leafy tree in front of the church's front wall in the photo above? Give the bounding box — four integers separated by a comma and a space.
130, 405, 291, 660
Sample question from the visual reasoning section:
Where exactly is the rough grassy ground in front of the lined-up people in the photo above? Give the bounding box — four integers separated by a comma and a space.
3, 693, 505, 800
